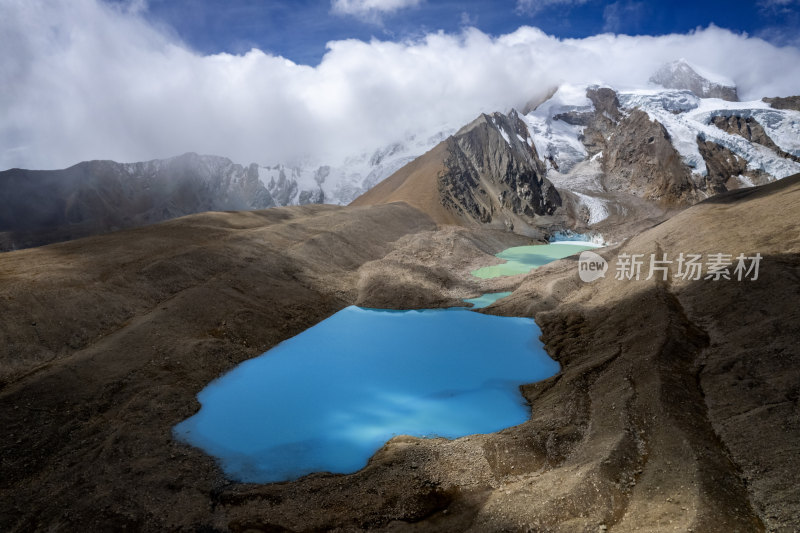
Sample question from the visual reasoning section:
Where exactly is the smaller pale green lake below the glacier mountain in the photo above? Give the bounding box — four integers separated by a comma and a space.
471, 241, 598, 279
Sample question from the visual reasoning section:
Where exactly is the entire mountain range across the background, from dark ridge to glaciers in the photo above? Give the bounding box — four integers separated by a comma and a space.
6, 60, 800, 250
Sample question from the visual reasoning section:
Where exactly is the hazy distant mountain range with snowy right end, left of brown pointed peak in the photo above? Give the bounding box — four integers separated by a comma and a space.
0, 133, 445, 251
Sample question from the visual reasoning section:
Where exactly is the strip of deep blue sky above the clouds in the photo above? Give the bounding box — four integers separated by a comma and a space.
131, 0, 800, 65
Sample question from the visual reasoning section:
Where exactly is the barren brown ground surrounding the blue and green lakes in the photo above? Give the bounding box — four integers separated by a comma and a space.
0, 178, 800, 532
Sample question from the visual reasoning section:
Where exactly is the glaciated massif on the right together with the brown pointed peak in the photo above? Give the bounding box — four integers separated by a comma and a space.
353, 61, 800, 238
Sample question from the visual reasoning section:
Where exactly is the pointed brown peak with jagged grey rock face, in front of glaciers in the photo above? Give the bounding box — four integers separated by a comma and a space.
351, 111, 561, 236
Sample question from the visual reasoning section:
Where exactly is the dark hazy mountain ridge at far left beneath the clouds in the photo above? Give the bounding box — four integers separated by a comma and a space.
0, 153, 276, 250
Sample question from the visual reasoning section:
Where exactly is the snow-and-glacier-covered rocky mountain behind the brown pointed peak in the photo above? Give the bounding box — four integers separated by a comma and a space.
521, 61, 800, 233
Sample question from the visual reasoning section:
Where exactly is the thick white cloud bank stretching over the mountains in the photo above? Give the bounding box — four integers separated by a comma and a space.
0, 0, 800, 169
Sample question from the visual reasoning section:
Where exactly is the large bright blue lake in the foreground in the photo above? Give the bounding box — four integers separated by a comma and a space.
173, 307, 559, 483
